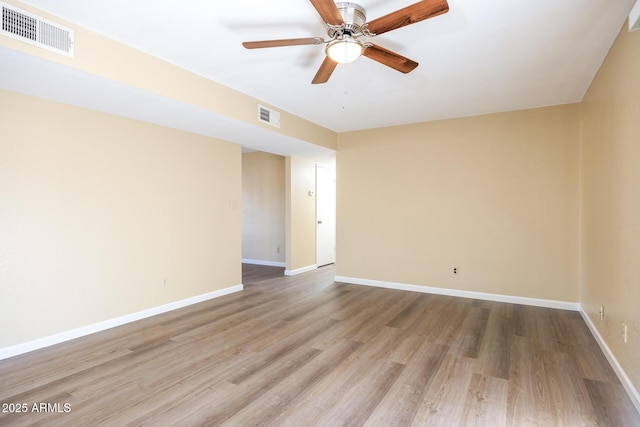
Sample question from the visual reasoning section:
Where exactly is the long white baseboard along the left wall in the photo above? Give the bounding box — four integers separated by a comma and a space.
0, 285, 244, 360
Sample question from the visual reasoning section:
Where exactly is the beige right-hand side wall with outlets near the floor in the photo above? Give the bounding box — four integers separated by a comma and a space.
581, 22, 640, 390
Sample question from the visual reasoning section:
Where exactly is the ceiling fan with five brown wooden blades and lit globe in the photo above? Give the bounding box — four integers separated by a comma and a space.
242, 0, 449, 84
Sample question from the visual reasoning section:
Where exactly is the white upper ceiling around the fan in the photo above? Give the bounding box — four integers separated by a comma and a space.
6, 0, 635, 140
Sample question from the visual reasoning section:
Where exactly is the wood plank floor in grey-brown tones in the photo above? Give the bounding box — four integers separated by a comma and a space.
0, 266, 640, 427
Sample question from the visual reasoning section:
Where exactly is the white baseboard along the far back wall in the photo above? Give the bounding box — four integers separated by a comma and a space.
335, 276, 580, 311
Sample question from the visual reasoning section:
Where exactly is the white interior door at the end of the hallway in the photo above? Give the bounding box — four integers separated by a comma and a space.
316, 165, 336, 267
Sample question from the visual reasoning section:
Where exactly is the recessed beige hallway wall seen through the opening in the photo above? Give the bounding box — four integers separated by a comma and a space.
242, 152, 285, 263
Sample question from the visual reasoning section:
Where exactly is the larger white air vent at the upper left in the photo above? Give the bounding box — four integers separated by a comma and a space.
0, 2, 73, 57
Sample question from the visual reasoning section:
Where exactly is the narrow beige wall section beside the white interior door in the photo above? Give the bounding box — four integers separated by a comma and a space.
285, 156, 316, 272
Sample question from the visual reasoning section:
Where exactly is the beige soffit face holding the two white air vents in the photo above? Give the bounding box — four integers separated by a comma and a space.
0, 0, 336, 150
